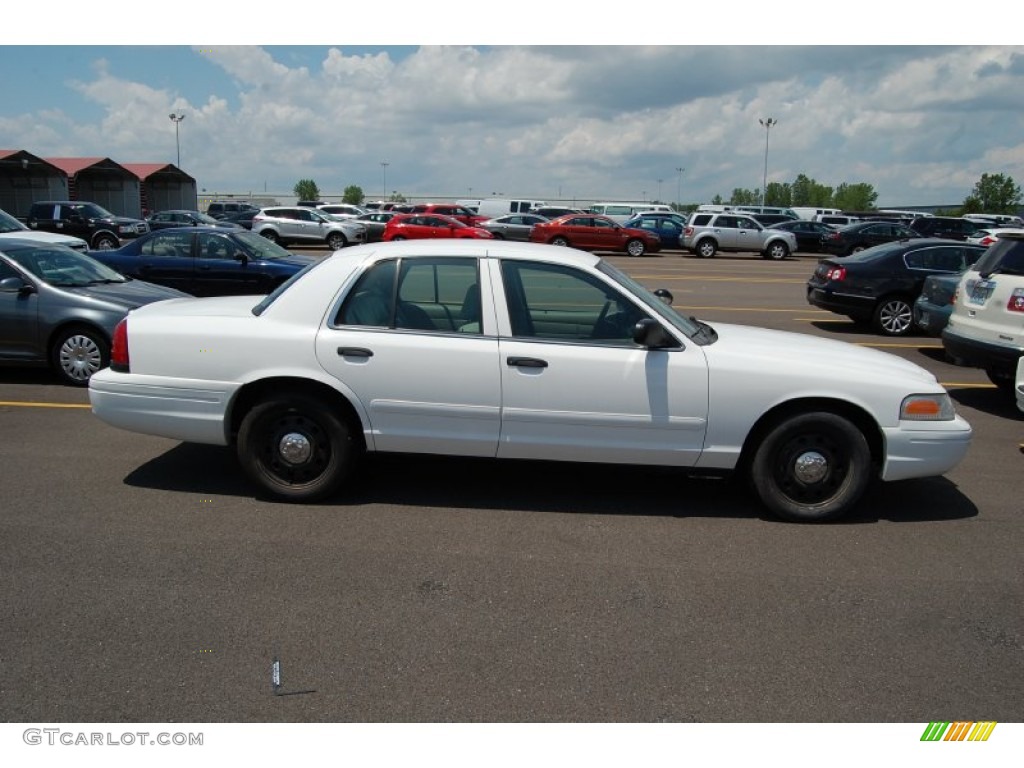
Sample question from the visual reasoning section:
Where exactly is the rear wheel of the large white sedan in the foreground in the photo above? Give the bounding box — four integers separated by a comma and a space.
237, 393, 356, 502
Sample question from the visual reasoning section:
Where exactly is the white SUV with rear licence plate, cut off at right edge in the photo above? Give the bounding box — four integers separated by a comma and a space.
942, 232, 1024, 391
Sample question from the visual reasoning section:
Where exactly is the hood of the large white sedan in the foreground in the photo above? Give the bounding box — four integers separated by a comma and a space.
703, 323, 941, 392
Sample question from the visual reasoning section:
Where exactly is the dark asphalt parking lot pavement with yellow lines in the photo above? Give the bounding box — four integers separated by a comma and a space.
0, 248, 1024, 723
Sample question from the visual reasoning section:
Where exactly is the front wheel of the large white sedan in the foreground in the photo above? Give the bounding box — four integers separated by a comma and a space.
750, 412, 871, 522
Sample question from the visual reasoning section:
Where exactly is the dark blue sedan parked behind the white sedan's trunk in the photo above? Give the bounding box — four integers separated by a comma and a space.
89, 226, 315, 296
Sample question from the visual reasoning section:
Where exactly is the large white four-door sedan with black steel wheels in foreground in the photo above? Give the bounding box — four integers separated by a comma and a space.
89, 240, 971, 520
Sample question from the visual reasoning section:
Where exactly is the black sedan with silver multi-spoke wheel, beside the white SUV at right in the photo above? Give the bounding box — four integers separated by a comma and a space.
807, 238, 985, 336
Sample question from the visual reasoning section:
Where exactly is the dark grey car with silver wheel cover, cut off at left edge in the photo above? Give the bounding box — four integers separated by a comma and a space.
0, 238, 185, 386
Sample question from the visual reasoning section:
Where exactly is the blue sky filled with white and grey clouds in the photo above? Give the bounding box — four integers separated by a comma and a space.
0, 24, 1024, 207
